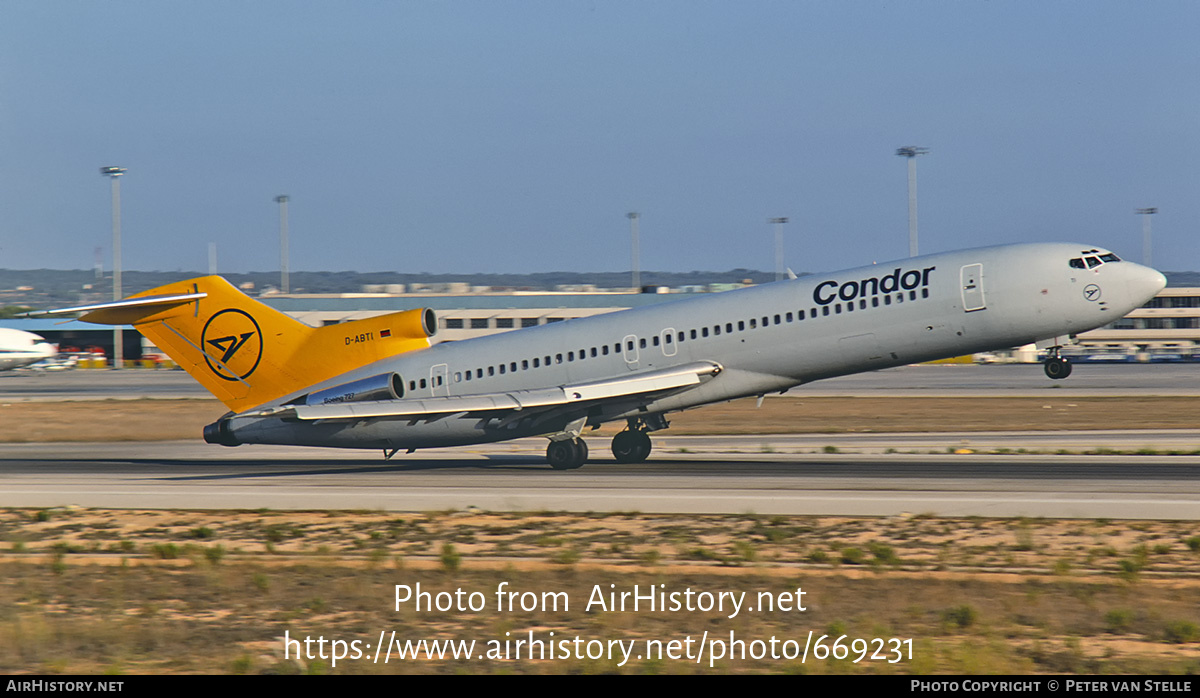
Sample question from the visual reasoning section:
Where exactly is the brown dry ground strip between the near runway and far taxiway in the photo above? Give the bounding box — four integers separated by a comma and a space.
0, 397, 1200, 443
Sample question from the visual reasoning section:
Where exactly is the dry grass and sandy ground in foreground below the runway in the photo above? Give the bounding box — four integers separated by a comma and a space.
0, 510, 1200, 674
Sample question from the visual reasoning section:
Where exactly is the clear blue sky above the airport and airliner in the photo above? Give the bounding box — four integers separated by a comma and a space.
0, 0, 1200, 272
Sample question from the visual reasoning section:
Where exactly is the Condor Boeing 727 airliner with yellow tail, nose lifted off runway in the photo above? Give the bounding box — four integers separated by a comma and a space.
35, 243, 1166, 469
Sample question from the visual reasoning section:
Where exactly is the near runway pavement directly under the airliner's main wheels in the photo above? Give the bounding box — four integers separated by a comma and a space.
0, 432, 1200, 521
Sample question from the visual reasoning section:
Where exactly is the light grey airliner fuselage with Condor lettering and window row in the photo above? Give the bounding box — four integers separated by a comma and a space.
229, 243, 1165, 449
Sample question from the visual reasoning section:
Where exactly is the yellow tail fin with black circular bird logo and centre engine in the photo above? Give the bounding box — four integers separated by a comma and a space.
80, 276, 437, 411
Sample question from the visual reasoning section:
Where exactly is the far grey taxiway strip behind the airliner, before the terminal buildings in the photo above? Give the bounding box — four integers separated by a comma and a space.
7, 363, 1200, 401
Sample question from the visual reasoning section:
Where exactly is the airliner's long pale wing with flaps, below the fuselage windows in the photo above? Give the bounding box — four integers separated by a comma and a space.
250, 361, 721, 426
